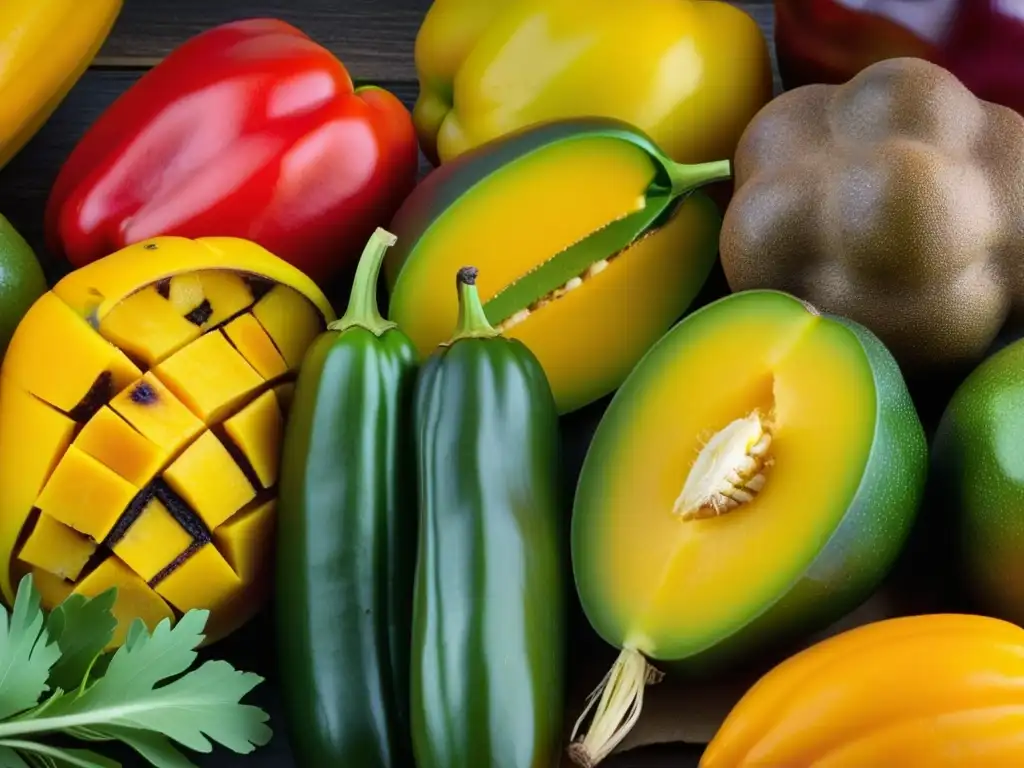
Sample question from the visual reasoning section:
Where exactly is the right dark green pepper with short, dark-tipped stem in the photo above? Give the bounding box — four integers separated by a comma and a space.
412, 267, 567, 768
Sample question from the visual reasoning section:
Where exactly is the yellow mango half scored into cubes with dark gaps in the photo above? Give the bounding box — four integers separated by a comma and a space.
0, 238, 335, 647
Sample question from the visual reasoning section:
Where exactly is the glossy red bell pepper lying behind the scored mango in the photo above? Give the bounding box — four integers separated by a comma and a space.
45, 18, 418, 284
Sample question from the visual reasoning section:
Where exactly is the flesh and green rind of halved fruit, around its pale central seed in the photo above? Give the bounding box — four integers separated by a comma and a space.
571, 291, 928, 676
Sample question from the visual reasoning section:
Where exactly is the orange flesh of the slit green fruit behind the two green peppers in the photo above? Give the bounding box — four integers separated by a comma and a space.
385, 128, 720, 413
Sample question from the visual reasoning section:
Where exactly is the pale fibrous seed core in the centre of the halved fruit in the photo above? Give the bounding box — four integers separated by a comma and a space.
673, 409, 772, 521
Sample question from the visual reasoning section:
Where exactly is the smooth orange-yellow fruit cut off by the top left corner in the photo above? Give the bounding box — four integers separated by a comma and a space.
0, 0, 123, 168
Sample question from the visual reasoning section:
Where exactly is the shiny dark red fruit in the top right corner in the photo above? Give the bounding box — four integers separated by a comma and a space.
775, 0, 1024, 113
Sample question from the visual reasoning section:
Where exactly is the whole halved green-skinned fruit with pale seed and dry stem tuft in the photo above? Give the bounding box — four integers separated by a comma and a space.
571, 291, 927, 765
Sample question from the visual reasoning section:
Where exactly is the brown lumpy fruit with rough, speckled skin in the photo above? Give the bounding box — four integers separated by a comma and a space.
720, 58, 1024, 374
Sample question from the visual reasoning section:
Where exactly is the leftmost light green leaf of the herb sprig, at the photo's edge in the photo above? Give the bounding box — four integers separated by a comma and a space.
0, 574, 60, 720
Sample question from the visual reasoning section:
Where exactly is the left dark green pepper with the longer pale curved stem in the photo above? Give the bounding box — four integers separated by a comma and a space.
274, 229, 417, 768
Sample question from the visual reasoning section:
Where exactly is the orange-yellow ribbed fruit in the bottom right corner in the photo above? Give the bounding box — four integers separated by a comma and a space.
700, 614, 1024, 768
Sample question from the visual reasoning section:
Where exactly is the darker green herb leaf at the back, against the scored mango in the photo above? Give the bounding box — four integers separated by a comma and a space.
46, 587, 118, 691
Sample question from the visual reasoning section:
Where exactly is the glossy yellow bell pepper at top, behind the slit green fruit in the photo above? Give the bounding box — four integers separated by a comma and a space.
414, 0, 772, 164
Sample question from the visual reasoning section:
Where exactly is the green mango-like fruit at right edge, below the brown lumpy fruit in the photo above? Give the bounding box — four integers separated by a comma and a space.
929, 341, 1024, 624
